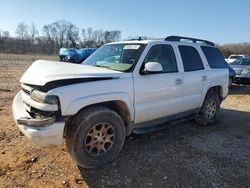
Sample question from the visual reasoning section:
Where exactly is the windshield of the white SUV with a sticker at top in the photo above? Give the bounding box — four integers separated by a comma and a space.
82, 44, 145, 72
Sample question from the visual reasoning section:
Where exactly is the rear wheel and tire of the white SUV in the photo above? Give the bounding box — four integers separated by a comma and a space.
196, 90, 221, 126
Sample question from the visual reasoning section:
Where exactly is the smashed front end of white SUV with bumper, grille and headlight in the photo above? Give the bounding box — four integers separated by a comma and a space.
13, 84, 65, 146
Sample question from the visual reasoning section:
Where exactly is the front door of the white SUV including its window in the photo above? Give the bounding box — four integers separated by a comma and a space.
134, 44, 183, 123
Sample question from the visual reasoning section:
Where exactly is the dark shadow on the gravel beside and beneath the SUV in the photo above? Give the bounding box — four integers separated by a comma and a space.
79, 109, 250, 187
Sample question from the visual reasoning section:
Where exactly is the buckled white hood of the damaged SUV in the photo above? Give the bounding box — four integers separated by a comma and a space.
20, 60, 122, 86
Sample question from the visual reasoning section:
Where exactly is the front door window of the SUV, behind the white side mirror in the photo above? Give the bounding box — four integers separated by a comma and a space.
144, 44, 178, 73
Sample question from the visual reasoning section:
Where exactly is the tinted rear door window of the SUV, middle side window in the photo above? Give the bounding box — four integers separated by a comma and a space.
179, 46, 204, 72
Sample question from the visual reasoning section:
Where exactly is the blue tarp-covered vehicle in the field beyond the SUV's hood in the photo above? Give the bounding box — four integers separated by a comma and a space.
58, 48, 97, 63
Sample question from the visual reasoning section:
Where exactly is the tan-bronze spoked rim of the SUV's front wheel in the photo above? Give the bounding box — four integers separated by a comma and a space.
84, 123, 115, 157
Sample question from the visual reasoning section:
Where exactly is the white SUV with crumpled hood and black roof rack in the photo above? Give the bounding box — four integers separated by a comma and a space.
13, 36, 228, 168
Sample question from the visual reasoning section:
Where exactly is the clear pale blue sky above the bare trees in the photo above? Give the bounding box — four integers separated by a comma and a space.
0, 0, 250, 44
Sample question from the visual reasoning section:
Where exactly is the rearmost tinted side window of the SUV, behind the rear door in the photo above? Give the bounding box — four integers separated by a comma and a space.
201, 46, 227, 69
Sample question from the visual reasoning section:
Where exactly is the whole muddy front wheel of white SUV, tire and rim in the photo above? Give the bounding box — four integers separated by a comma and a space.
66, 106, 125, 168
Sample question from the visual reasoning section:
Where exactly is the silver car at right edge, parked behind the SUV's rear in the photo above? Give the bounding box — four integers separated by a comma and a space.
230, 57, 250, 85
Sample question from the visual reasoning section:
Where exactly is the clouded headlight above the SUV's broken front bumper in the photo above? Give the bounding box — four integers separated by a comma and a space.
30, 90, 58, 104
